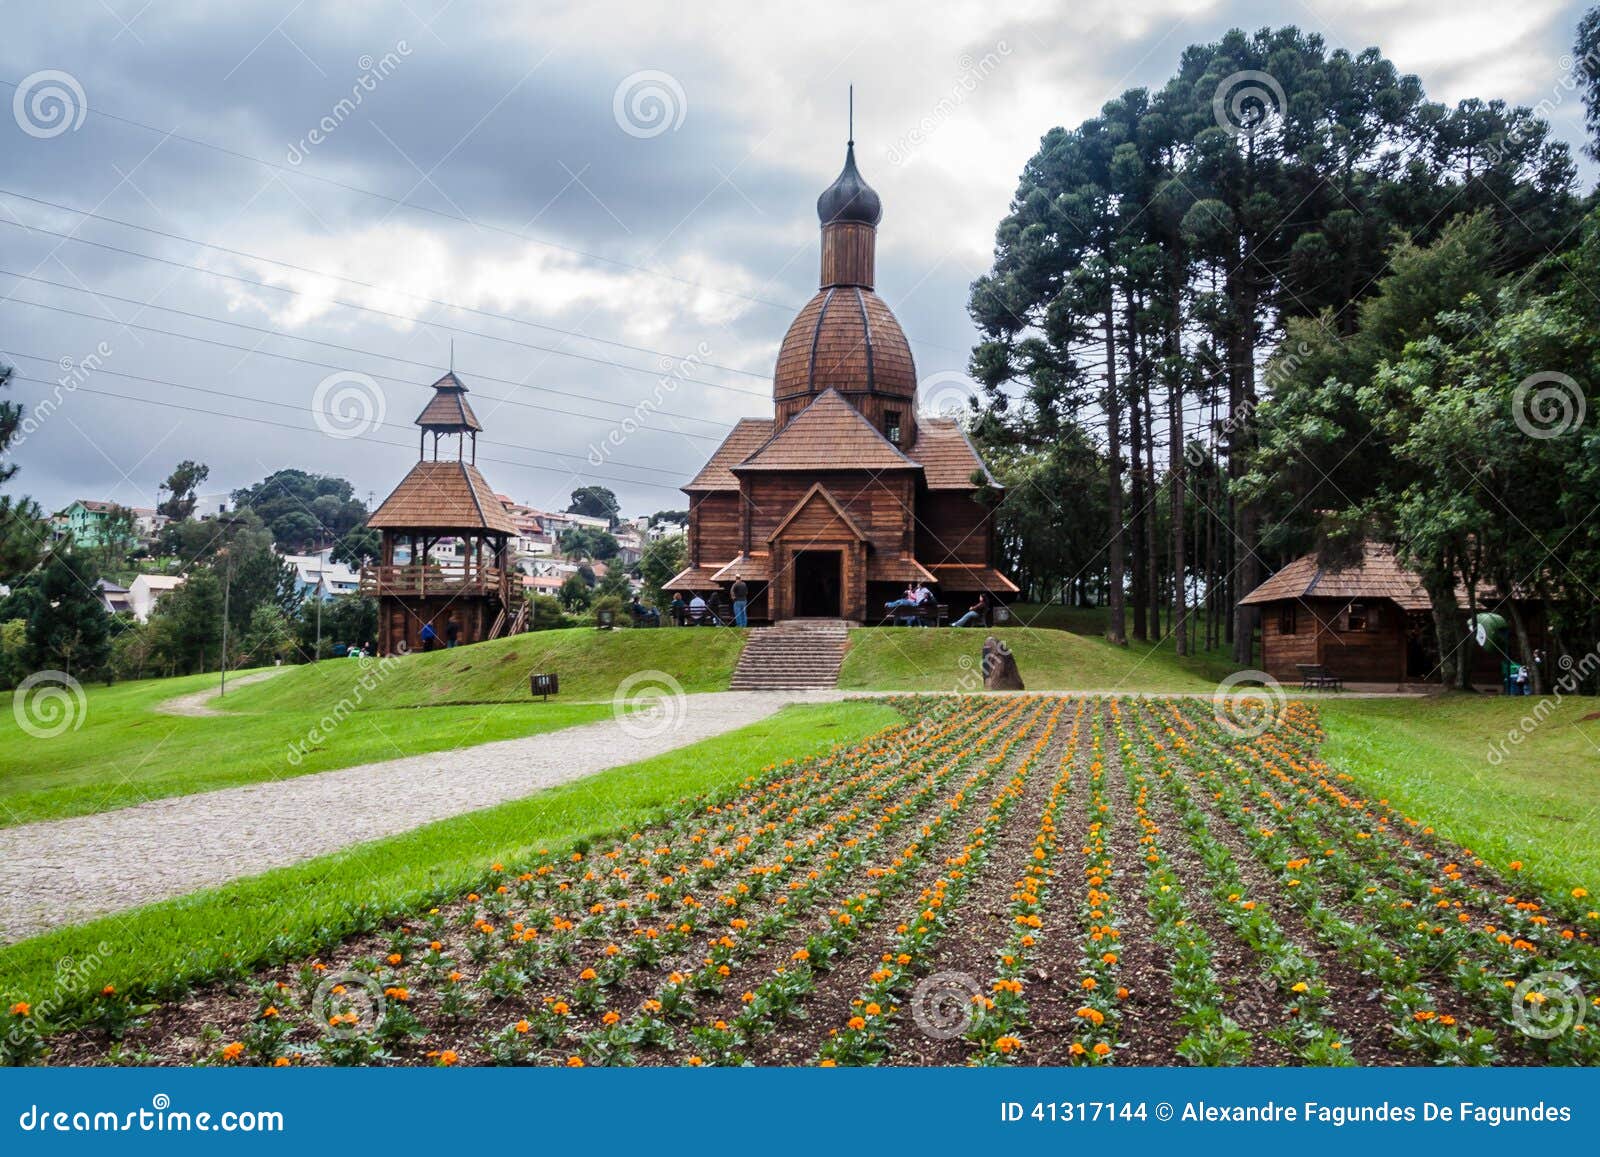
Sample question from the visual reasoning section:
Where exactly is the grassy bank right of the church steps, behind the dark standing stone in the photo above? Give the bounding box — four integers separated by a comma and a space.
838, 627, 1234, 691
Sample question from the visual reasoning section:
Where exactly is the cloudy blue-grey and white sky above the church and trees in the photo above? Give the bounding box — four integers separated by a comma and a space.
0, 0, 1594, 514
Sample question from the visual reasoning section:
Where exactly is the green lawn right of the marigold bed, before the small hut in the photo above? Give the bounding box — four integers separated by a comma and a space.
1320, 695, 1600, 895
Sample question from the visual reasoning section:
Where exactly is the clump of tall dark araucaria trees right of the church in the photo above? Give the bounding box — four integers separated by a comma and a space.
971, 27, 1579, 664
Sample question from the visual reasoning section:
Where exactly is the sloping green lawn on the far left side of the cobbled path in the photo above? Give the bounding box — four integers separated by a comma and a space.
0, 629, 744, 827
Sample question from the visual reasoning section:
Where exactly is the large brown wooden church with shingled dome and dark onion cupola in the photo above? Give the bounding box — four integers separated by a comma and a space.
667, 141, 1018, 623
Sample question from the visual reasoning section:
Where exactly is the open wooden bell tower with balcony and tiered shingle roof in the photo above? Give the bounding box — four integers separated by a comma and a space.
362, 370, 525, 655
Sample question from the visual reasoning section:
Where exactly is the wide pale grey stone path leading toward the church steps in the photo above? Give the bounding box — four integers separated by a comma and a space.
0, 691, 842, 943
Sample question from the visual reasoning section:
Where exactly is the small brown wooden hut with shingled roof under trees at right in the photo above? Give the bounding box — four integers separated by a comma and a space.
1240, 544, 1544, 685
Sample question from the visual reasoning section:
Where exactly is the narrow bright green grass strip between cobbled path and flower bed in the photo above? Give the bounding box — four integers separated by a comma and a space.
0, 703, 901, 1005
